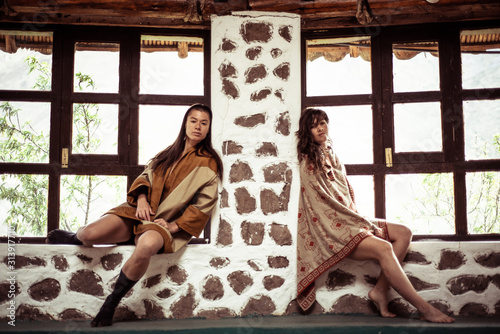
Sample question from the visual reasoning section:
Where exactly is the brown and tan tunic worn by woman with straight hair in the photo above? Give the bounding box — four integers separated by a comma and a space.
107, 148, 218, 253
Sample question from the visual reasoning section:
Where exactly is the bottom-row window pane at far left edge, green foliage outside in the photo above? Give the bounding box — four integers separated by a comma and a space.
0, 174, 49, 237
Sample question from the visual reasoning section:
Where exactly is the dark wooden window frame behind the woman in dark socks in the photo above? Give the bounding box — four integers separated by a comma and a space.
0, 24, 211, 244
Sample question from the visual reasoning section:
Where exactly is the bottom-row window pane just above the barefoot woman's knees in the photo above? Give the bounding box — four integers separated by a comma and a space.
386, 173, 455, 234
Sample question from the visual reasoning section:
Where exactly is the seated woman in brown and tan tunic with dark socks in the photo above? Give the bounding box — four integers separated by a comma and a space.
47, 104, 222, 327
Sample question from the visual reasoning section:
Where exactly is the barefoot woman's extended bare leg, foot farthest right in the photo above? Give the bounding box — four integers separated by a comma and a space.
349, 237, 455, 323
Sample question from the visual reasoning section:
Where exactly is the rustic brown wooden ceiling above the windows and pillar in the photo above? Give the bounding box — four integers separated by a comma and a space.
0, 0, 500, 30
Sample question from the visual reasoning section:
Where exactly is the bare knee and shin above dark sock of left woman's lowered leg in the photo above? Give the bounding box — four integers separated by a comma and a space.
122, 230, 163, 281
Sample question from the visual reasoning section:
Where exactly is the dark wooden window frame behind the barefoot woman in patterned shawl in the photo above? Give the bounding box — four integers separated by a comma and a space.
301, 20, 500, 241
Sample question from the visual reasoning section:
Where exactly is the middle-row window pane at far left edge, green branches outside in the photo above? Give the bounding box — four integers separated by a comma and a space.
0, 101, 50, 163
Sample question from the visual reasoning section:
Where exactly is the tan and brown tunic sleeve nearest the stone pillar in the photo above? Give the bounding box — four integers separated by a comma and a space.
176, 174, 218, 237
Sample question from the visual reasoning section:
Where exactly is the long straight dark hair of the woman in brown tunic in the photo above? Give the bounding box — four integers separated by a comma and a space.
152, 103, 224, 179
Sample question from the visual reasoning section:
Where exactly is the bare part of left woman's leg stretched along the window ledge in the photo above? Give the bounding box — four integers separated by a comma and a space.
76, 214, 134, 246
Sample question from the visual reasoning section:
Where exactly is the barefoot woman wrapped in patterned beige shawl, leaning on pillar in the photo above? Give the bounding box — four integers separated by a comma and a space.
297, 108, 454, 323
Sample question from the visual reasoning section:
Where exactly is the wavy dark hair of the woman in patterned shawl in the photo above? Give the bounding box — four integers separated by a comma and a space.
295, 108, 329, 169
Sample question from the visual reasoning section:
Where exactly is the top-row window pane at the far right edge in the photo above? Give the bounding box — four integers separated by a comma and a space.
460, 28, 500, 89
